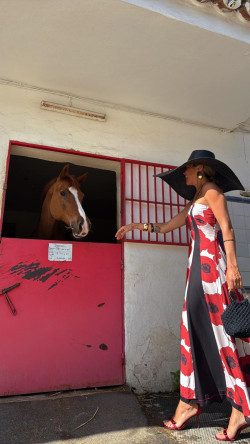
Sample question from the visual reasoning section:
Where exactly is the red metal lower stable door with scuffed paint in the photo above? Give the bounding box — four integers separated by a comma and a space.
0, 238, 124, 396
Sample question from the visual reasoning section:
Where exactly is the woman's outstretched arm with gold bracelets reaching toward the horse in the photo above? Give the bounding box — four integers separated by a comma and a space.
115, 202, 191, 240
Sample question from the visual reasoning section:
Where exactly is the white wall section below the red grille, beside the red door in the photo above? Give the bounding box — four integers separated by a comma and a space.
125, 243, 188, 393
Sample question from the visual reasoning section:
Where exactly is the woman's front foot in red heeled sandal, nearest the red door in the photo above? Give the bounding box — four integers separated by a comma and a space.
163, 400, 201, 430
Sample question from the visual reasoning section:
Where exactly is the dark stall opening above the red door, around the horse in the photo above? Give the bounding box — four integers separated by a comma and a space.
2, 154, 117, 243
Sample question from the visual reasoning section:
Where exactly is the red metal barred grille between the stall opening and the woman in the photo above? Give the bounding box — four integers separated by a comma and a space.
122, 160, 187, 245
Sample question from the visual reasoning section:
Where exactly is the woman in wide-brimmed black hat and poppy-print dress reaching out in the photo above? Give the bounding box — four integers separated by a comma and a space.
116, 150, 250, 441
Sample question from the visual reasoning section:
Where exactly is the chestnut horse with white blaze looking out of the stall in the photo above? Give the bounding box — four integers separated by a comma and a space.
37, 165, 91, 240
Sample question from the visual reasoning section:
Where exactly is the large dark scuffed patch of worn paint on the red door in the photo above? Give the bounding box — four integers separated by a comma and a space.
8, 262, 76, 290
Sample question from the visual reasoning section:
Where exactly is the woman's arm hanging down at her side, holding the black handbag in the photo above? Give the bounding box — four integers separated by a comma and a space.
204, 186, 242, 289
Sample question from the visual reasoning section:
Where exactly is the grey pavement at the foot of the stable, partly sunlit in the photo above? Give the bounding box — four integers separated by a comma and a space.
0, 386, 250, 444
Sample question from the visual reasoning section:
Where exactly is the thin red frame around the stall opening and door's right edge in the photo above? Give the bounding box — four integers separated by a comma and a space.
0, 140, 125, 383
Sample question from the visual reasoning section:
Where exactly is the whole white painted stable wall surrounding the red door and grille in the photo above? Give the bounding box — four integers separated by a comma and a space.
0, 85, 250, 392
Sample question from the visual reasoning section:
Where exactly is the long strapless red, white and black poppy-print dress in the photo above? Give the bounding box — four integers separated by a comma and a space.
180, 203, 250, 421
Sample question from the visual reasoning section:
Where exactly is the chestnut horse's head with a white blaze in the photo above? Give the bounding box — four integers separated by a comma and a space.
50, 165, 90, 239
